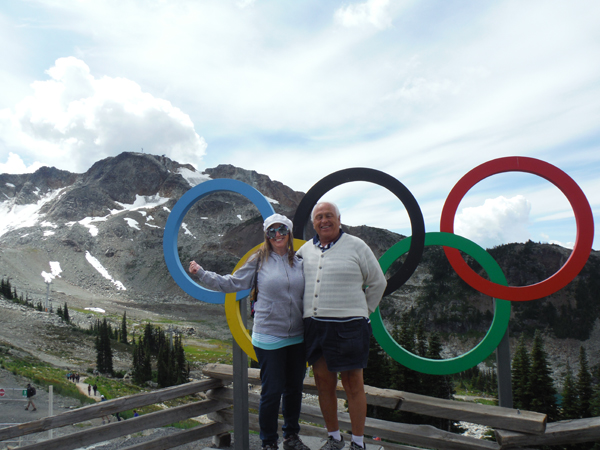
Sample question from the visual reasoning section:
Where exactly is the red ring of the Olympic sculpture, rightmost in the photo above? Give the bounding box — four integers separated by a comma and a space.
440, 156, 594, 302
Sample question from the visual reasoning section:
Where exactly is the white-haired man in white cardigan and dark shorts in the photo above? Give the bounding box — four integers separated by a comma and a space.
298, 202, 386, 450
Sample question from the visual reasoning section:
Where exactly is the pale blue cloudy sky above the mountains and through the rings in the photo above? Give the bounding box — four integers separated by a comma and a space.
0, 0, 600, 249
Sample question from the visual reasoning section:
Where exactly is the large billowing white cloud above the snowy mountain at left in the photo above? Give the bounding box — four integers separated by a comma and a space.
0, 57, 206, 173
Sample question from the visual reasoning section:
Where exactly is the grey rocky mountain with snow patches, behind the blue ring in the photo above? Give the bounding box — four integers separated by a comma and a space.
0, 153, 310, 301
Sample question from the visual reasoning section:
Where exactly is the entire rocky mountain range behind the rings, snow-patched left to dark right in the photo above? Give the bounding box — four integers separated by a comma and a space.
0, 153, 600, 380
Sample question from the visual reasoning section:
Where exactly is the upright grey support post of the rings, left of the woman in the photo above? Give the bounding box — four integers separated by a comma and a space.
233, 298, 250, 450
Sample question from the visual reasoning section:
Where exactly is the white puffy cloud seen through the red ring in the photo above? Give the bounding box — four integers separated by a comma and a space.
454, 195, 531, 248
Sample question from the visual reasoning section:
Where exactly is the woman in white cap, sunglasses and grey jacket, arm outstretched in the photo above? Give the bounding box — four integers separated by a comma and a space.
189, 214, 309, 450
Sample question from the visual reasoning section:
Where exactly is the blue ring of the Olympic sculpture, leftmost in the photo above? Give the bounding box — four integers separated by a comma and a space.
163, 178, 275, 304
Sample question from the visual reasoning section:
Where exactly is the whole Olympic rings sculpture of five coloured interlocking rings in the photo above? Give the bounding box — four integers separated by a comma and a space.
163, 156, 594, 375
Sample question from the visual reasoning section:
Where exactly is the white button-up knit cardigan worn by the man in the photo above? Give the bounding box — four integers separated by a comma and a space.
297, 233, 387, 319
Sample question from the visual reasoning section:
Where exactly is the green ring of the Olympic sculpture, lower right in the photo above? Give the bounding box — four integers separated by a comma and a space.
370, 232, 511, 375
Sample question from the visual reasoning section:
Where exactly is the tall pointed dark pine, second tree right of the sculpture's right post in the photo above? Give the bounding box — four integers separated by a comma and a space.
529, 330, 559, 422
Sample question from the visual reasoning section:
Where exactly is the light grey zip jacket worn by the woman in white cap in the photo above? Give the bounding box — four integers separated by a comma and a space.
197, 252, 304, 338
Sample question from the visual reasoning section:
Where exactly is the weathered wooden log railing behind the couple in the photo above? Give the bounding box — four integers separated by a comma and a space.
0, 364, 600, 450
